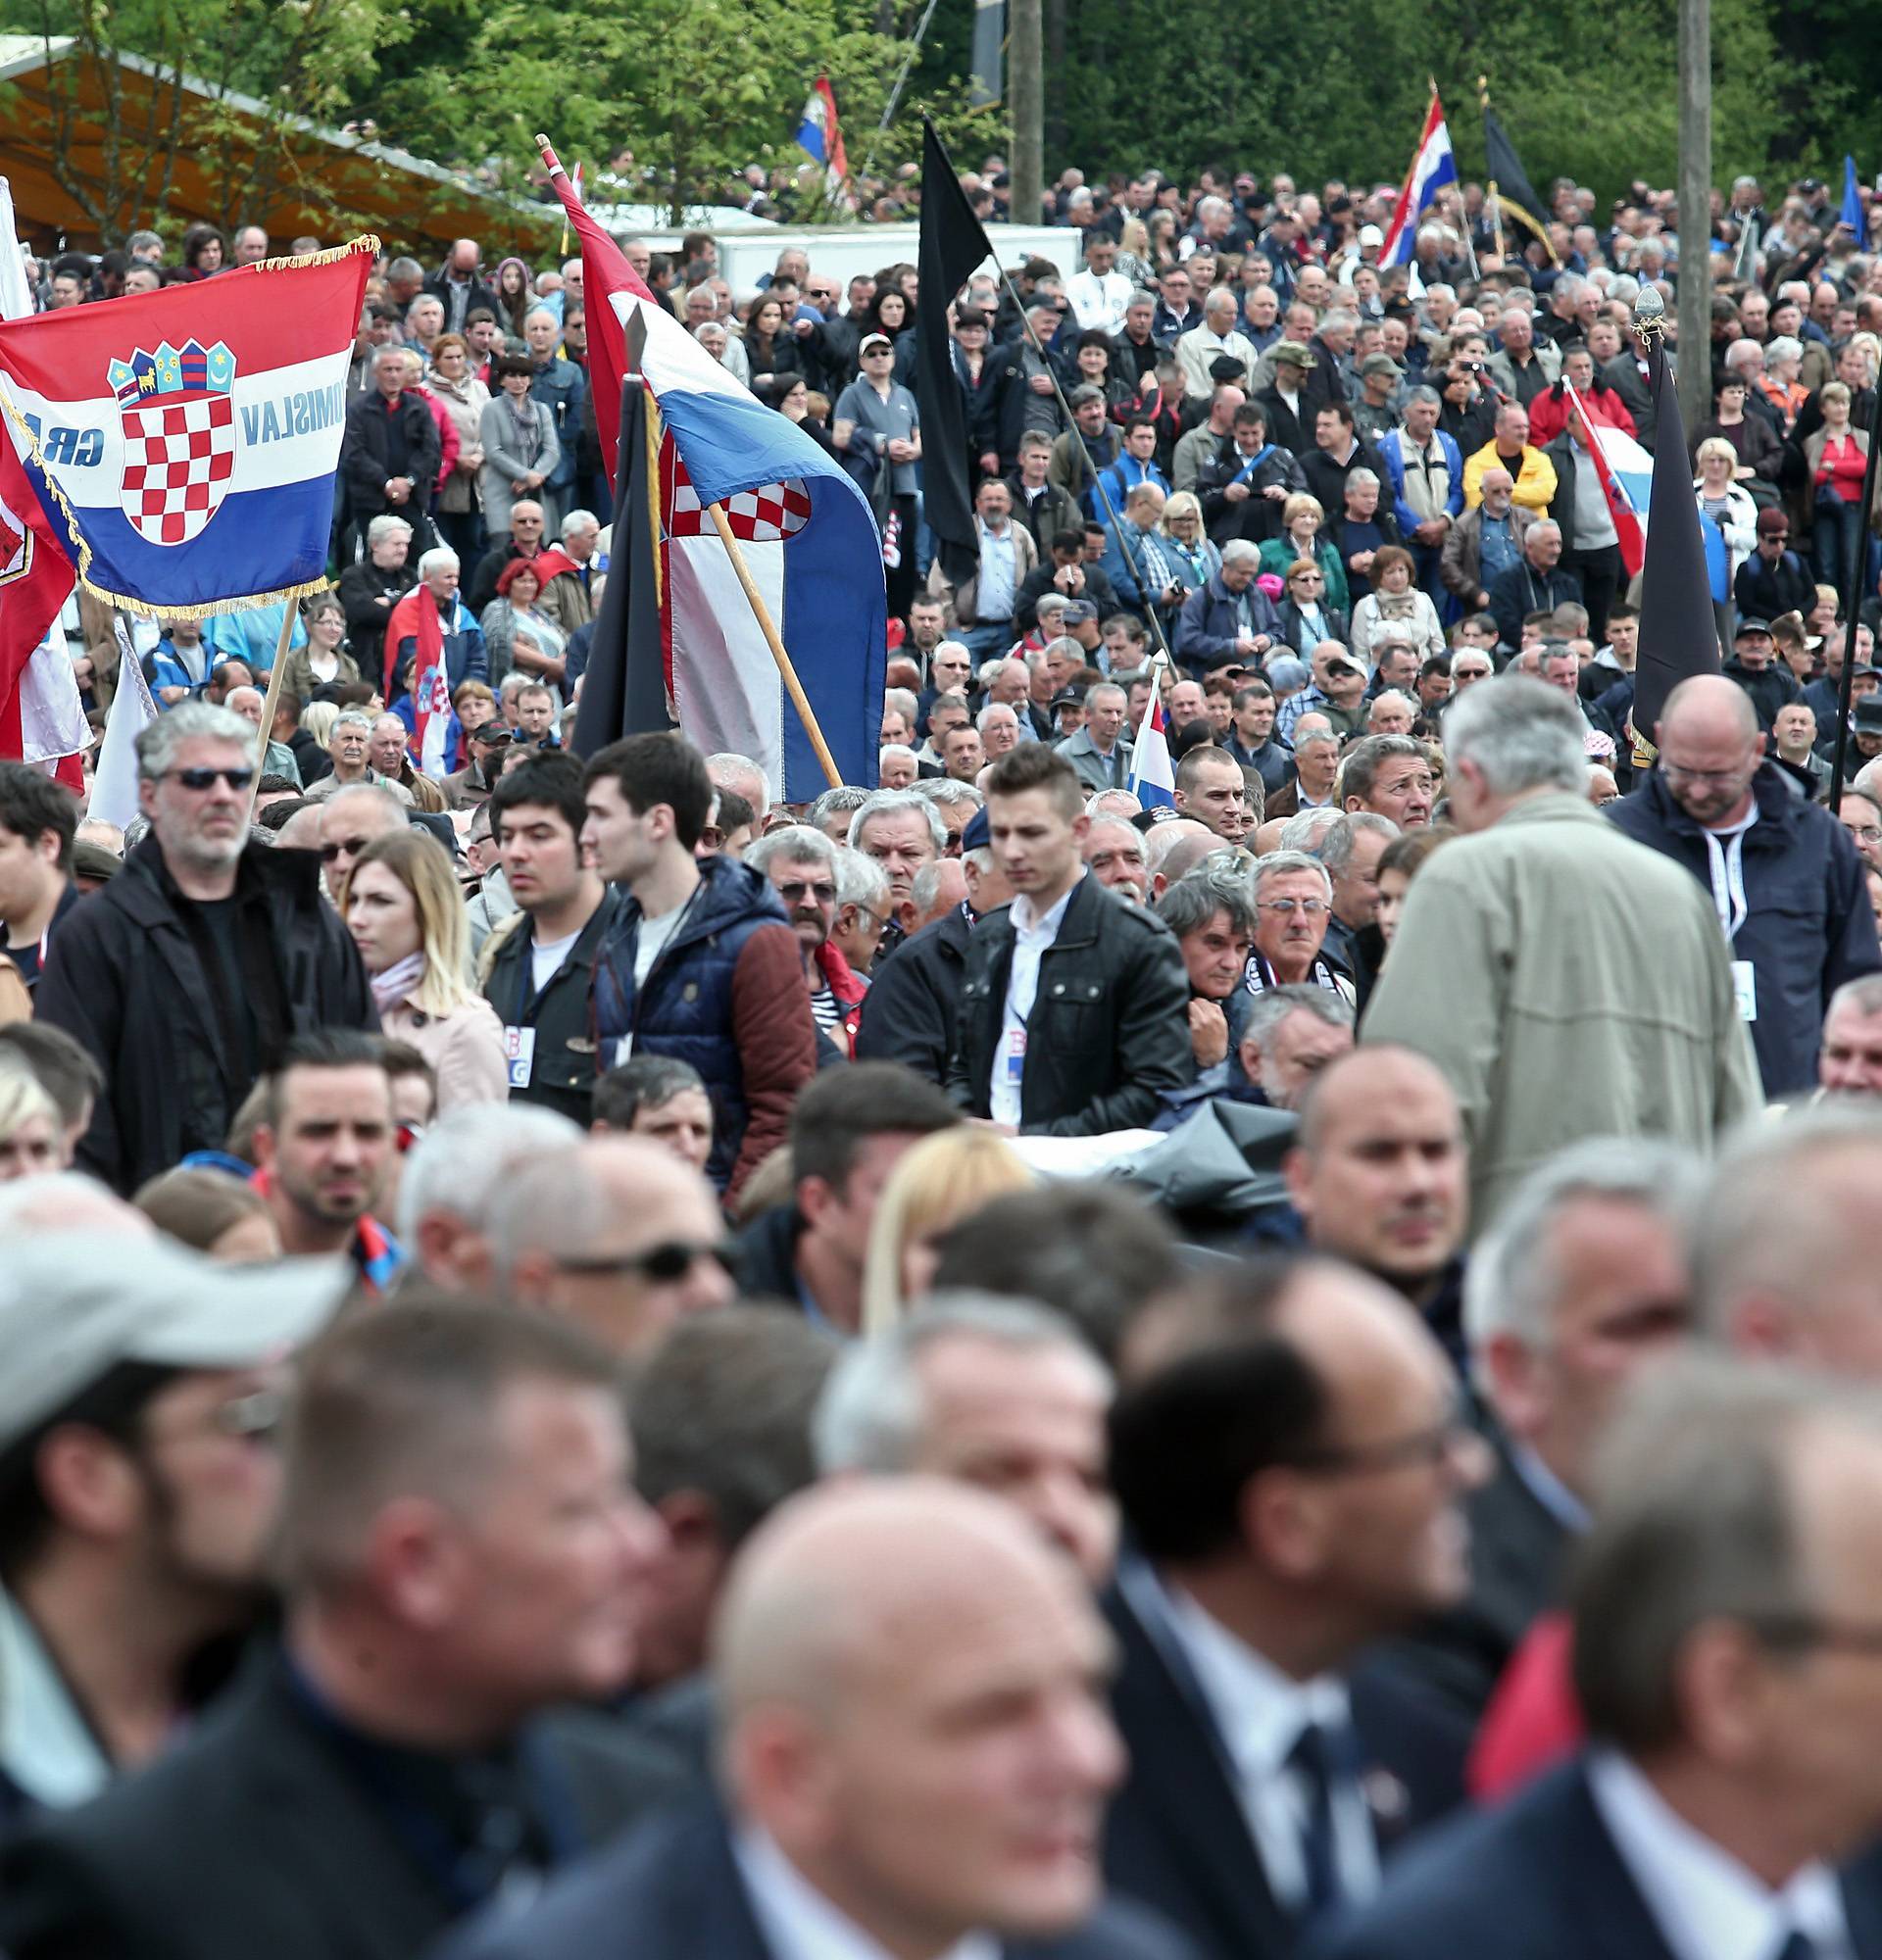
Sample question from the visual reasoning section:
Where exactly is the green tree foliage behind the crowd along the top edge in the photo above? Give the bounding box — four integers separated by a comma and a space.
11, 0, 1882, 243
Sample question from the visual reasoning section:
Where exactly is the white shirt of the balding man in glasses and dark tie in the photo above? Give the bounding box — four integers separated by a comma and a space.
1119, 1560, 1378, 1915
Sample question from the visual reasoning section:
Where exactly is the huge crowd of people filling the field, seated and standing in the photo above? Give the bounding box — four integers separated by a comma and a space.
11, 159, 1882, 1960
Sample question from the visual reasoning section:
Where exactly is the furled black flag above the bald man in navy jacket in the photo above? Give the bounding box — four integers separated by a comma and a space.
1633, 335, 1719, 743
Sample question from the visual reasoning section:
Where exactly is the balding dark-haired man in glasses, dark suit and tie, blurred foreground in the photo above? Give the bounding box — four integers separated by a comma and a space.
1104, 1258, 1488, 1960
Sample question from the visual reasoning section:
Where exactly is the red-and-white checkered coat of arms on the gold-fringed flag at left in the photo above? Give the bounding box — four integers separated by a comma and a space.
110, 341, 237, 545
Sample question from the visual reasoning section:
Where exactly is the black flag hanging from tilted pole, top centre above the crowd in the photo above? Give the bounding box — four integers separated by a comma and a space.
916, 118, 994, 586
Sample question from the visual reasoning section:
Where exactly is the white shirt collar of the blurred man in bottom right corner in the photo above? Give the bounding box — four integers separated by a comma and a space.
1588, 1750, 1855, 1960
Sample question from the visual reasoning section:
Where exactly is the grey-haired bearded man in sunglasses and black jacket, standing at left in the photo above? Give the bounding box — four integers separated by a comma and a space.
35, 702, 378, 1192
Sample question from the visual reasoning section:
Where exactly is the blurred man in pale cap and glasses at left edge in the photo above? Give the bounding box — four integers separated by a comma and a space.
0, 1215, 347, 1819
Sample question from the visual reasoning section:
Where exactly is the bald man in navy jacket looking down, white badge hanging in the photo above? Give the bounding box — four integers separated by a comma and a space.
1606, 674, 1882, 1098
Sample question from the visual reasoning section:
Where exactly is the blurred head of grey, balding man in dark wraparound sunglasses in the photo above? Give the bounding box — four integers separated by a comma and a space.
492, 1135, 735, 1358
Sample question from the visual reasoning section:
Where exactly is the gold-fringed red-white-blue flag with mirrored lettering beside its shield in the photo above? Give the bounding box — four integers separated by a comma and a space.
0, 239, 378, 615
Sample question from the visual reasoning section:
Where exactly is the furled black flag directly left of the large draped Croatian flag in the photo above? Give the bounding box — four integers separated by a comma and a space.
574, 368, 672, 757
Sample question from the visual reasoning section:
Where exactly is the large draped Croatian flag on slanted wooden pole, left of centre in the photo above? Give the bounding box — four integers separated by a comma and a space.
543, 134, 886, 804
